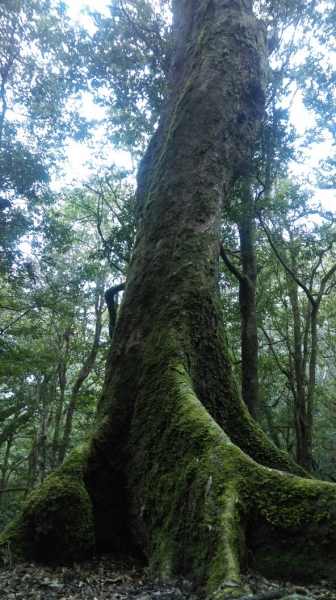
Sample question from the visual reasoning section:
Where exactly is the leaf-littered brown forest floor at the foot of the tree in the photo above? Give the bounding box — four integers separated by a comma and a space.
0, 555, 336, 600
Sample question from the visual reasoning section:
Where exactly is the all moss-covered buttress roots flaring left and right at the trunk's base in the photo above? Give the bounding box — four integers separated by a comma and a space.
1, 346, 336, 598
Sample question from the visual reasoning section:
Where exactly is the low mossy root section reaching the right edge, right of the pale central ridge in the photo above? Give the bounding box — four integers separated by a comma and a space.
242, 468, 336, 580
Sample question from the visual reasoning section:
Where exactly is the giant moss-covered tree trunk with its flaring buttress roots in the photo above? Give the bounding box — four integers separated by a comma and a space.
2, 0, 336, 597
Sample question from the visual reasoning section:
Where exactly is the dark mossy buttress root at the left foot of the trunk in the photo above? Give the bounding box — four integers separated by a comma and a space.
0, 445, 94, 564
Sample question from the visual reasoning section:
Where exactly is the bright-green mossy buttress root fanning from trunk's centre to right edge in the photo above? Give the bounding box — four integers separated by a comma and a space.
129, 342, 336, 597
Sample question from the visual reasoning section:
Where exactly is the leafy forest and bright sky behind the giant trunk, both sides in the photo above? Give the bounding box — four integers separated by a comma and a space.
0, 0, 336, 568
